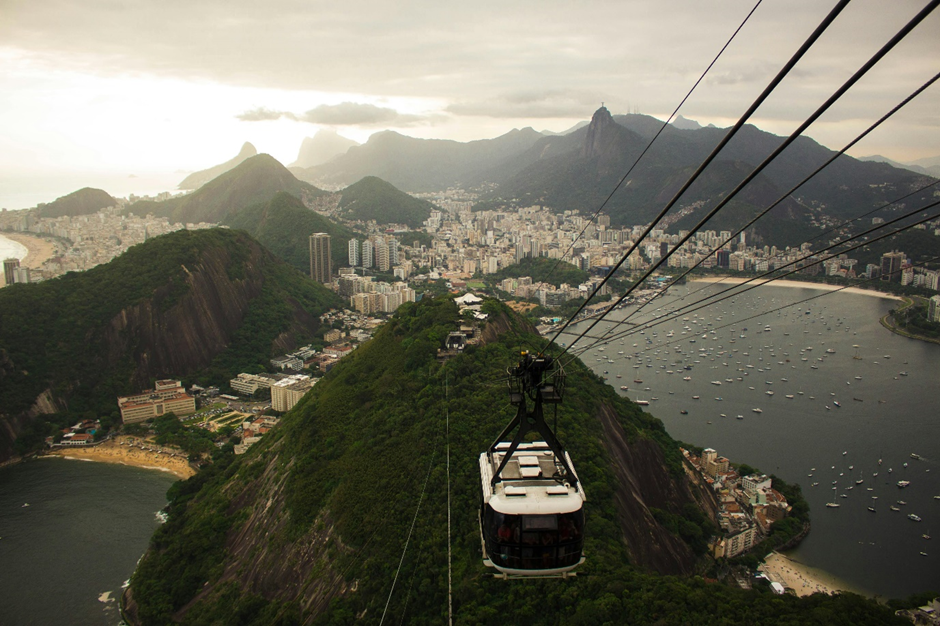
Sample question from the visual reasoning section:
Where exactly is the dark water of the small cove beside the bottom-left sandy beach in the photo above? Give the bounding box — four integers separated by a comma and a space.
0, 458, 176, 626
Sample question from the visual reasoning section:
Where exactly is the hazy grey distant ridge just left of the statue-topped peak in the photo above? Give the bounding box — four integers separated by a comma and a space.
296, 128, 542, 192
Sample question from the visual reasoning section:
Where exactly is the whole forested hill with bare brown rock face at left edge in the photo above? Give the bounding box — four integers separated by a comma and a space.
0, 229, 338, 460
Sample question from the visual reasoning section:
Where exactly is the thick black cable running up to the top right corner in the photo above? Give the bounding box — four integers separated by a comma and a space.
560, 0, 940, 360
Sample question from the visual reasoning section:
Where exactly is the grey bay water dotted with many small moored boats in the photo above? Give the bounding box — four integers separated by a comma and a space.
561, 283, 940, 597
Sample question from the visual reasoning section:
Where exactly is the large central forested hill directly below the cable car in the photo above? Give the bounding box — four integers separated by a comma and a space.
127, 297, 893, 626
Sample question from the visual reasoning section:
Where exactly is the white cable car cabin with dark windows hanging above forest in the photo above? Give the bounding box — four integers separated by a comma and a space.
480, 441, 586, 578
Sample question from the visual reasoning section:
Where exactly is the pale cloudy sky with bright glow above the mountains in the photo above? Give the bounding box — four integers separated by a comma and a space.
0, 0, 940, 208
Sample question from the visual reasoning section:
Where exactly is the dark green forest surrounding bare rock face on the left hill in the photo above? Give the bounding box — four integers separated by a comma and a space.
0, 229, 338, 424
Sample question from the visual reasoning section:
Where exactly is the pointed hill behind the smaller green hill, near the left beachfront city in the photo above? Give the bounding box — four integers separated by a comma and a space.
127, 154, 328, 223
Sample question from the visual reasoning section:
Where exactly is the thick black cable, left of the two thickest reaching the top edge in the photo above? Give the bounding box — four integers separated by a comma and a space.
549, 0, 852, 354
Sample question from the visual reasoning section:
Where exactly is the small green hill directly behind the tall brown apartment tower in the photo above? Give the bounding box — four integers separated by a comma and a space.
224, 191, 355, 273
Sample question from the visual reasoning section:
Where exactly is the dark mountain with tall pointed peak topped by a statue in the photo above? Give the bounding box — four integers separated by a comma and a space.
478, 108, 927, 245
